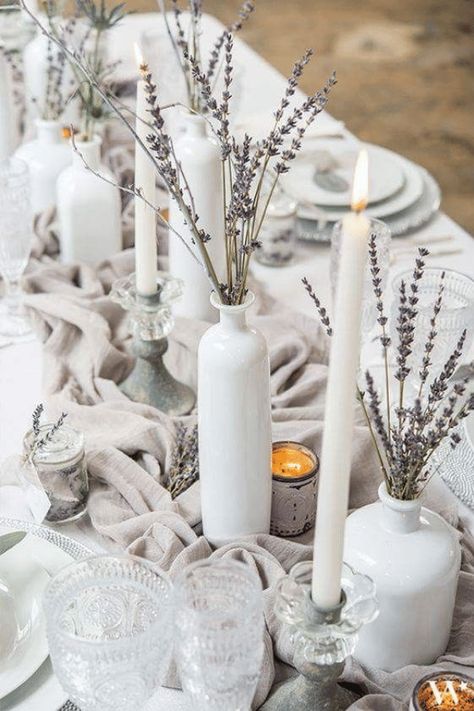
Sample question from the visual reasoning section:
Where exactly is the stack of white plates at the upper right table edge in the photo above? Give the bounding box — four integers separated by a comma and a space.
283, 141, 441, 241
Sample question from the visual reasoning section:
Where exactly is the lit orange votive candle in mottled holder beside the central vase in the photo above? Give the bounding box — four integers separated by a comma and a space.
270, 441, 319, 537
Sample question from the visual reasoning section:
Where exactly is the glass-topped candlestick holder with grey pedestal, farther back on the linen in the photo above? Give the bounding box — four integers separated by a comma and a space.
110, 272, 196, 416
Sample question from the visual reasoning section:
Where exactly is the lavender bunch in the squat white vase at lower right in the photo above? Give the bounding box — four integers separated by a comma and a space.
303, 245, 474, 500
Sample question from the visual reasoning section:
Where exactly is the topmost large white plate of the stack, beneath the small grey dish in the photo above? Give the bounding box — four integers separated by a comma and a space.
282, 144, 406, 209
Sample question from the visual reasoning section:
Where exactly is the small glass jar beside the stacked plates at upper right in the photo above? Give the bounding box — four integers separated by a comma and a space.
255, 194, 297, 267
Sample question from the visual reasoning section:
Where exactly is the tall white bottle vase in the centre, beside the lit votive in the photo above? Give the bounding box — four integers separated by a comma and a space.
198, 293, 272, 545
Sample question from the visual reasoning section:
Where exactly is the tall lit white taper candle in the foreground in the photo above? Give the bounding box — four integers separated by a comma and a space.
312, 151, 370, 610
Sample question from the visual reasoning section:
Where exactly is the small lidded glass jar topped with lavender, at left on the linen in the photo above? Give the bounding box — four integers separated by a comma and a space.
23, 423, 89, 523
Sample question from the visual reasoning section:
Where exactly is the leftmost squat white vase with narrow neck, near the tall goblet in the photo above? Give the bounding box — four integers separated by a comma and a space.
15, 119, 71, 214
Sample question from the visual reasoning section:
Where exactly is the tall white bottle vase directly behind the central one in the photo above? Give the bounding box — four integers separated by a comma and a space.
168, 114, 225, 323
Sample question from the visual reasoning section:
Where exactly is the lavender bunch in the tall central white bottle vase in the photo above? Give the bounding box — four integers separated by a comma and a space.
20, 0, 334, 304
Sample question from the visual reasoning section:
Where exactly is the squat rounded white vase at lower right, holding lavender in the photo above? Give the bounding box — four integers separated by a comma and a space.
344, 484, 461, 672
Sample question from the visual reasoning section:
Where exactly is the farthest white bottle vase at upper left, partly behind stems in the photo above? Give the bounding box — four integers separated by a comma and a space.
23, 30, 80, 126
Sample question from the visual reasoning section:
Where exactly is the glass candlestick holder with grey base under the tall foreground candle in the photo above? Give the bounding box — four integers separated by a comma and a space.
261, 562, 378, 711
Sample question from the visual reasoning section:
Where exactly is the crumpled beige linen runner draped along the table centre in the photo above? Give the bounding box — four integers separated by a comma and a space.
19, 232, 474, 711
